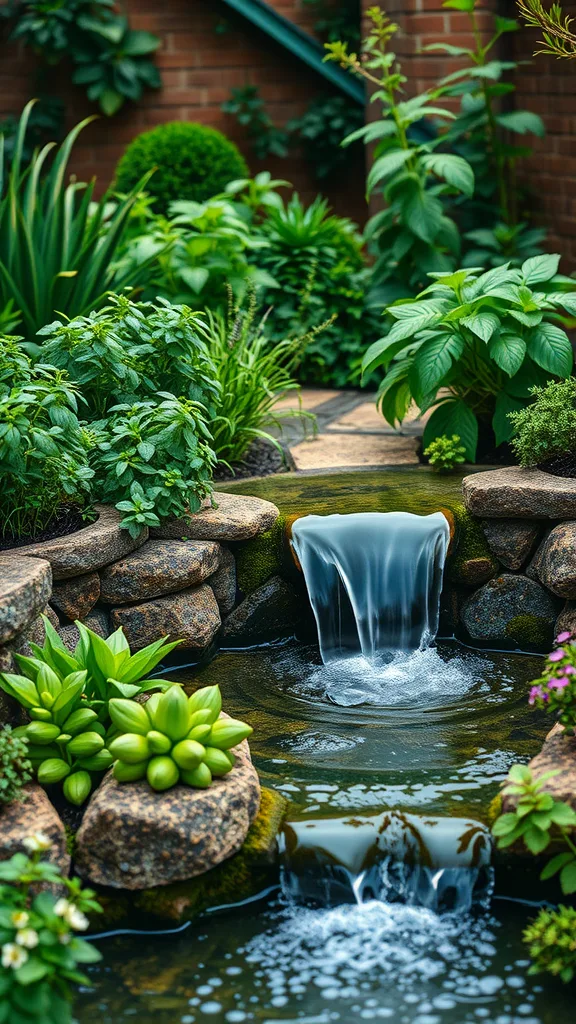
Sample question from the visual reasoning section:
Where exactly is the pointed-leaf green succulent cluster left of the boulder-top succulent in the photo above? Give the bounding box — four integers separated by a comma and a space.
0, 616, 180, 806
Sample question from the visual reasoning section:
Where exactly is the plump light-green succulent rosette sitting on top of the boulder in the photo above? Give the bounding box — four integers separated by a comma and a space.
109, 683, 253, 792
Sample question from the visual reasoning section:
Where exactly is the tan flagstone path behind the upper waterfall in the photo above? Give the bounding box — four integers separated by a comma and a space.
276, 388, 425, 472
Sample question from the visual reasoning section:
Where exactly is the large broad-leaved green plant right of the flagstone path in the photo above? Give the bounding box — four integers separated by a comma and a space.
363, 255, 576, 462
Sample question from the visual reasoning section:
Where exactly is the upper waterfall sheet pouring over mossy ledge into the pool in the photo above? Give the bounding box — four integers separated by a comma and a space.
292, 512, 450, 664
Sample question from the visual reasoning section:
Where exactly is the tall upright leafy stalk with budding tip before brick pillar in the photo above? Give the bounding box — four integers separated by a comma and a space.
326, 7, 475, 303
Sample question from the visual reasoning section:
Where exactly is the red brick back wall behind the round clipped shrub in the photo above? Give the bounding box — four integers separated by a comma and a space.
0, 0, 366, 220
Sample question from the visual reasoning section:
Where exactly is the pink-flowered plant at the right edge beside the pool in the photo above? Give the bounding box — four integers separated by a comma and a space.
529, 631, 576, 736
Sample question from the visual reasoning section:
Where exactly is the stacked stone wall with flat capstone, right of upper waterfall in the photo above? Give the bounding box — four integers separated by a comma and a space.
460, 467, 576, 646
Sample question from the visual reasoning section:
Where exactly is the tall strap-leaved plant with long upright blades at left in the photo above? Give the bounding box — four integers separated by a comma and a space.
0, 100, 154, 337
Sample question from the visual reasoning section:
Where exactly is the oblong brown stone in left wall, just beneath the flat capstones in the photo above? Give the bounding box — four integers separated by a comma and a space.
100, 541, 221, 604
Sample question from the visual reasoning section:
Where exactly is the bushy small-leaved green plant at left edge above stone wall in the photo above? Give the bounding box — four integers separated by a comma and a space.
0, 337, 93, 540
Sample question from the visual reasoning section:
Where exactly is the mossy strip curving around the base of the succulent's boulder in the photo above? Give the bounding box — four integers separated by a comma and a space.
133, 790, 287, 923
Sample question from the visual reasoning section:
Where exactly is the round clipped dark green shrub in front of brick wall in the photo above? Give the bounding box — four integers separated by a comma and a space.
115, 121, 249, 213
